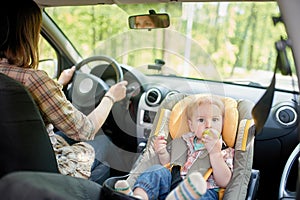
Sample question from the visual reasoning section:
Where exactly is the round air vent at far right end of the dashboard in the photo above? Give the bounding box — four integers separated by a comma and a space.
275, 106, 298, 127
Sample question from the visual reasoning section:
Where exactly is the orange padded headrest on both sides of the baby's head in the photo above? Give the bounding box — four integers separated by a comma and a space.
169, 94, 239, 147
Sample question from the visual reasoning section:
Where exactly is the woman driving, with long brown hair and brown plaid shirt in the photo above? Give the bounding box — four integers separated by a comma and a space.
0, 1, 127, 182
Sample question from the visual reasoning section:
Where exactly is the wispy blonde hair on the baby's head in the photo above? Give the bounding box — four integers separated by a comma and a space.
186, 95, 225, 119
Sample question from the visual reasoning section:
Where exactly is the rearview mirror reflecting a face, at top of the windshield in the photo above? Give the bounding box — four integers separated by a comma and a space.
128, 13, 170, 29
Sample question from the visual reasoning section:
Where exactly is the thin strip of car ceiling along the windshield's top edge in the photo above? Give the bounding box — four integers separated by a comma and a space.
34, 0, 274, 7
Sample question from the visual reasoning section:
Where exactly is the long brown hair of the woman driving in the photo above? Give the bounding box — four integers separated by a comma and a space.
0, 1, 42, 69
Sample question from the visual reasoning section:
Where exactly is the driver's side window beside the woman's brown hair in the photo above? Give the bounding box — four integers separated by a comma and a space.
38, 36, 57, 78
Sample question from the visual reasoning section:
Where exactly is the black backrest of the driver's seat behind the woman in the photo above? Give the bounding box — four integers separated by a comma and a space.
0, 73, 59, 178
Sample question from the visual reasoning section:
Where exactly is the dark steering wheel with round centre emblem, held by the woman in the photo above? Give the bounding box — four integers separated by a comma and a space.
67, 55, 123, 115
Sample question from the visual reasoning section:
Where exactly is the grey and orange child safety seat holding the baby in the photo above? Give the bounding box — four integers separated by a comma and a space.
101, 94, 259, 200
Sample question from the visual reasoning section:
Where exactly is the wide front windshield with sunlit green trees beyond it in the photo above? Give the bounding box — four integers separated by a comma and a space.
46, 2, 298, 91
